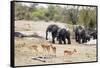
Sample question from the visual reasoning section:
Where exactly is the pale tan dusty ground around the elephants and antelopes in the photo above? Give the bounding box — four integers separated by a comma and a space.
15, 21, 96, 66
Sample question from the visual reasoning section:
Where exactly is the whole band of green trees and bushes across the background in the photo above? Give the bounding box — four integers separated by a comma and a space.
15, 3, 96, 28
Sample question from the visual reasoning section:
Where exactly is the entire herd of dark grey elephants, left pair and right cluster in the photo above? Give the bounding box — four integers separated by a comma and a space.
46, 24, 97, 44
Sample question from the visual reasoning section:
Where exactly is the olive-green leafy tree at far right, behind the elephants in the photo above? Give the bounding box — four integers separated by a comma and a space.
79, 6, 96, 28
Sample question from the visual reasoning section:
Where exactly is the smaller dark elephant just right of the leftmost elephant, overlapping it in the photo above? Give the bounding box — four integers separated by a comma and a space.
57, 28, 71, 44
